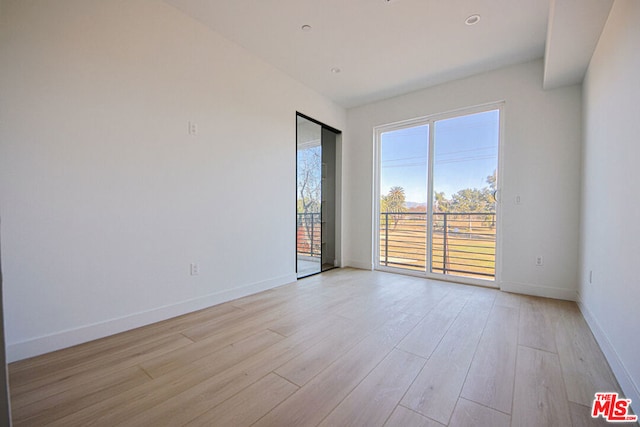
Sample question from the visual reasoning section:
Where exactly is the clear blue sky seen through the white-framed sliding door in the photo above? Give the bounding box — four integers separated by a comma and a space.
380, 110, 499, 203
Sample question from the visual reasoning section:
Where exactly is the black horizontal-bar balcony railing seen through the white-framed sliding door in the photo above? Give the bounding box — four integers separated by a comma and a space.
379, 212, 496, 278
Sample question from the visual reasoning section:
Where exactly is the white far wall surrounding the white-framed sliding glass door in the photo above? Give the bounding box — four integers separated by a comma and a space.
343, 61, 581, 299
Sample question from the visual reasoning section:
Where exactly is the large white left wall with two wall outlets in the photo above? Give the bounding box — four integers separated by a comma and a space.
0, 0, 346, 360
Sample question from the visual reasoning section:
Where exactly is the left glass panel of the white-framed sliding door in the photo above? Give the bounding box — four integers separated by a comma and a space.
376, 125, 429, 272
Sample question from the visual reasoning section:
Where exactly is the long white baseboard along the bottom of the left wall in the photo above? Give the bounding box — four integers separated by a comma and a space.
6, 273, 296, 362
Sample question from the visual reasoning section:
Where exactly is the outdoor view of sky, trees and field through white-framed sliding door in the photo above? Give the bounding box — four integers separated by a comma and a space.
378, 110, 500, 280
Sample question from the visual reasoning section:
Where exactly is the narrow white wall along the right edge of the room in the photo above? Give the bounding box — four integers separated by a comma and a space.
579, 0, 640, 414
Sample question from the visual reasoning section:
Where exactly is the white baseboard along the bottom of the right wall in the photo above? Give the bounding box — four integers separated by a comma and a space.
577, 294, 640, 420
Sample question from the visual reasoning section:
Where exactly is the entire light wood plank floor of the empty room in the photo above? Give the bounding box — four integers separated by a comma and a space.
9, 269, 620, 427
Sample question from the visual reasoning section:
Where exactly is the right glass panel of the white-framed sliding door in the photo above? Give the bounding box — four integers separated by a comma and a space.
430, 110, 500, 280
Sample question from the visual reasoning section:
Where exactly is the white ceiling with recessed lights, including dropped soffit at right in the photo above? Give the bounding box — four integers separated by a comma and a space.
165, 0, 612, 108
